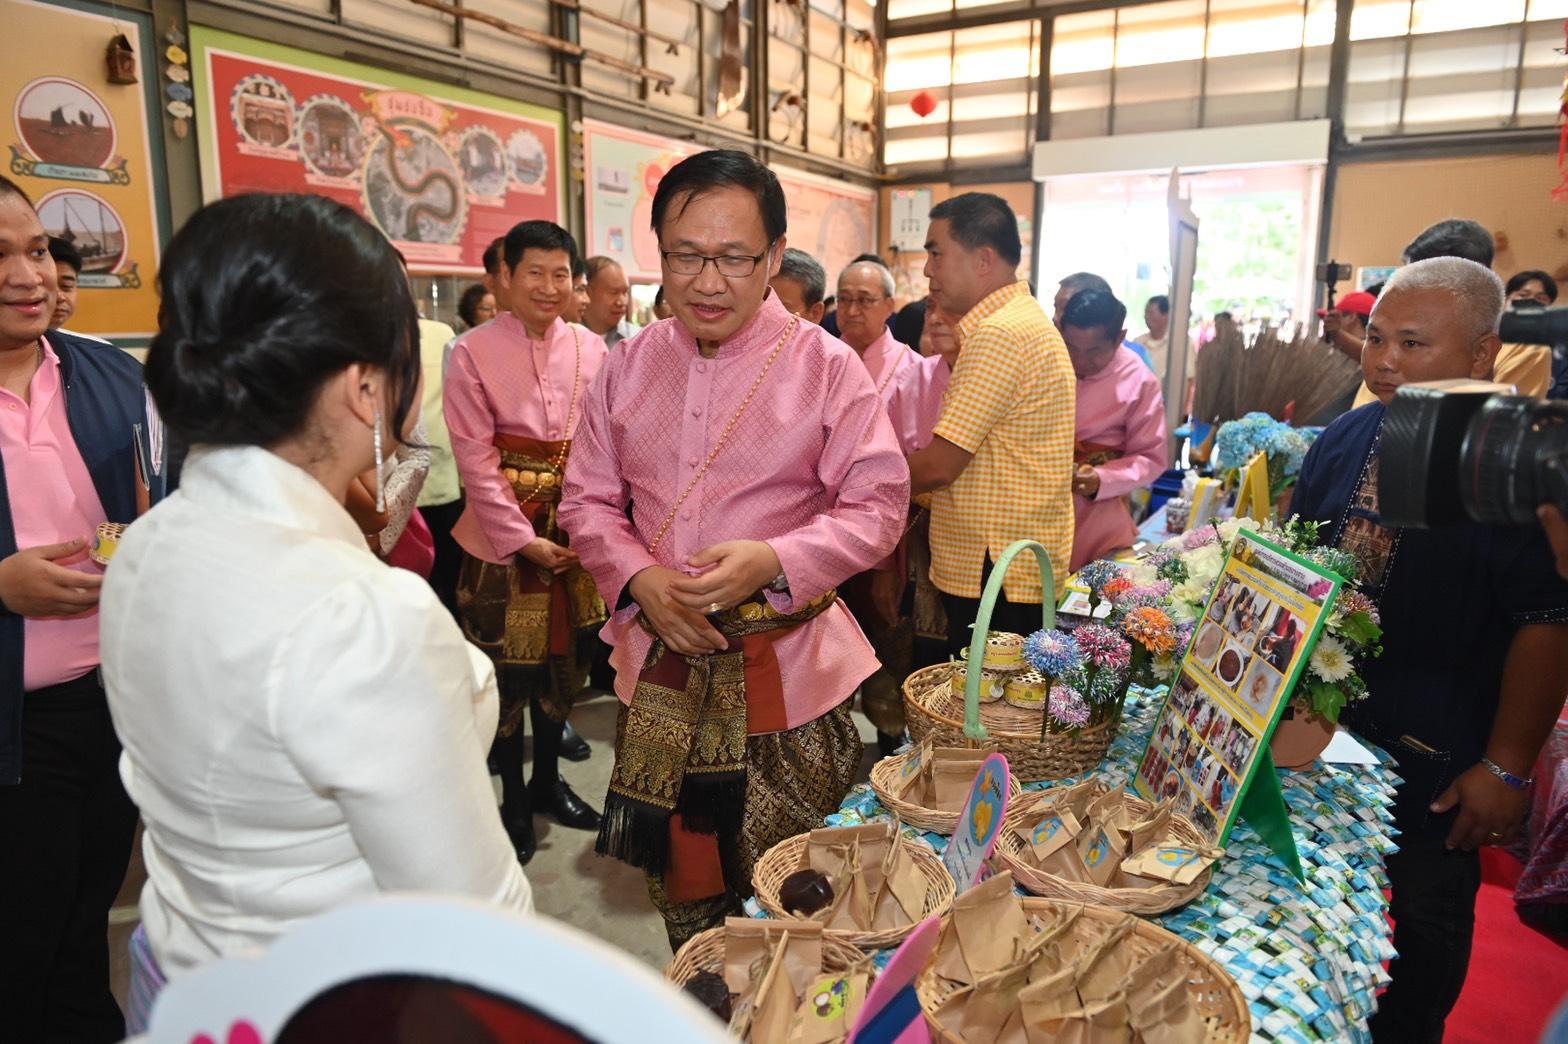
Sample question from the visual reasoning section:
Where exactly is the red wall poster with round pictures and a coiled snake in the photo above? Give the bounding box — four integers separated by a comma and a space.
193, 30, 561, 271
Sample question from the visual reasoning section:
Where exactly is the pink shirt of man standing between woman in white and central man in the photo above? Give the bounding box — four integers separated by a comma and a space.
442, 312, 608, 564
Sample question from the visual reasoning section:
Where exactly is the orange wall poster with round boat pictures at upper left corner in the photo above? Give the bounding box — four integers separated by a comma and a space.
0, 0, 168, 343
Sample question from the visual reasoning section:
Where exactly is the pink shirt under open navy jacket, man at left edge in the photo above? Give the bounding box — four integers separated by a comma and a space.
0, 337, 108, 693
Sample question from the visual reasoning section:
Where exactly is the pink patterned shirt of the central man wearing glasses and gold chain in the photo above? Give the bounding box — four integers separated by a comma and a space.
560, 293, 909, 729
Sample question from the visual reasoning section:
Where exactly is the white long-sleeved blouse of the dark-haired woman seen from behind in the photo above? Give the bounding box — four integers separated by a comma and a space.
102, 447, 533, 977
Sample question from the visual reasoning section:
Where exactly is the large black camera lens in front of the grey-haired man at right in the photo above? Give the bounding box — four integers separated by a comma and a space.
1458, 395, 1568, 525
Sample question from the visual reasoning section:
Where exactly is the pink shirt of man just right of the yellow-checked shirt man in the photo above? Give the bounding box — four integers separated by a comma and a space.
1073, 348, 1170, 569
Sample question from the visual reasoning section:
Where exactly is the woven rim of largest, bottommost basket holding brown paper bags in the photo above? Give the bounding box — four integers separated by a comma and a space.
916, 898, 1253, 1044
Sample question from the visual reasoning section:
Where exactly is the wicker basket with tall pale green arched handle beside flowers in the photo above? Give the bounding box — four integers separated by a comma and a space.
903, 541, 1121, 782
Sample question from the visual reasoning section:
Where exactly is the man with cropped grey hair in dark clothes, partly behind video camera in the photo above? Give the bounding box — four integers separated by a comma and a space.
1292, 257, 1568, 1041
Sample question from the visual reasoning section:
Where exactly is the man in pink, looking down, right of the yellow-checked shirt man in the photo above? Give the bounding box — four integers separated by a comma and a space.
1062, 290, 1170, 569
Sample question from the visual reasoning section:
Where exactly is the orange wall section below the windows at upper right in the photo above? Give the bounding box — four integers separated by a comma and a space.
1330, 154, 1568, 279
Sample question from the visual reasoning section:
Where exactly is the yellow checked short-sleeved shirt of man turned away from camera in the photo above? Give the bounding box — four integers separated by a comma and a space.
931, 282, 1077, 604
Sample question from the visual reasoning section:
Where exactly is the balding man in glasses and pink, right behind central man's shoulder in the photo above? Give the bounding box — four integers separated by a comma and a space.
834, 260, 952, 756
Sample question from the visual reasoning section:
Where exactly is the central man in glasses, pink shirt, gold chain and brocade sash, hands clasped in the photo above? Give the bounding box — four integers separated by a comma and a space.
561, 150, 909, 947
